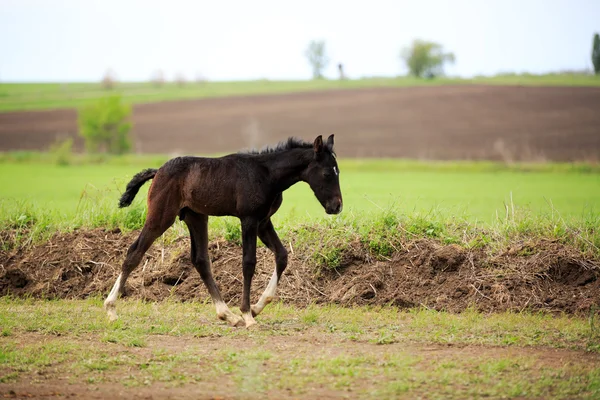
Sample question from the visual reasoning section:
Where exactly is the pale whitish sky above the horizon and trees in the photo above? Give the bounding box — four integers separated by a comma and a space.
0, 0, 600, 82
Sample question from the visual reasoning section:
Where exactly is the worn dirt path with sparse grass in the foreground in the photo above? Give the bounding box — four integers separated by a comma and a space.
0, 327, 600, 399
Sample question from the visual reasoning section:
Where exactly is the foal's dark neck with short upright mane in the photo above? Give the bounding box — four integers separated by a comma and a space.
264, 148, 314, 192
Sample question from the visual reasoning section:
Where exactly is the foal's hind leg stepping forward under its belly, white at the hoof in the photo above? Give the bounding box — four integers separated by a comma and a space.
184, 209, 245, 326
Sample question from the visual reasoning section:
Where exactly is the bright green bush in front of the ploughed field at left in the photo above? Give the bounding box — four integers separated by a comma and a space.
78, 95, 131, 154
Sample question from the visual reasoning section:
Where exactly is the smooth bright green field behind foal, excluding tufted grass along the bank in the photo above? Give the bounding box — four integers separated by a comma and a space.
0, 158, 600, 228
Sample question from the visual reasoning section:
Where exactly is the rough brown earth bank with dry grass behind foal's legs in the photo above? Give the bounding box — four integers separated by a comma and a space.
0, 229, 600, 315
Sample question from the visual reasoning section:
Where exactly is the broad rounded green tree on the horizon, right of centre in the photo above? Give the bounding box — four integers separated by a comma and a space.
400, 39, 454, 78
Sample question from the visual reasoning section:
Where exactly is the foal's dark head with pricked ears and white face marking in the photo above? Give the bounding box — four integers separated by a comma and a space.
306, 135, 342, 214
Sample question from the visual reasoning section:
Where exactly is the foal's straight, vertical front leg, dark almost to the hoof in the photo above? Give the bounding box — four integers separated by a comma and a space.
240, 218, 258, 328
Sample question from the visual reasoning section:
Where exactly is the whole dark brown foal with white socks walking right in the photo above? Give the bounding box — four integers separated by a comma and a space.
104, 135, 342, 327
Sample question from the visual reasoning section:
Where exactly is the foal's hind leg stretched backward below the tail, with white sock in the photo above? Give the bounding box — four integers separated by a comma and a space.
104, 202, 177, 321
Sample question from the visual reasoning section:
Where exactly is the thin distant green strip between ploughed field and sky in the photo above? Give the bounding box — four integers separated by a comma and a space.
0, 74, 600, 112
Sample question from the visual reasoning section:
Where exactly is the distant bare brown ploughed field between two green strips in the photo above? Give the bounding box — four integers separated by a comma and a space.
0, 85, 600, 161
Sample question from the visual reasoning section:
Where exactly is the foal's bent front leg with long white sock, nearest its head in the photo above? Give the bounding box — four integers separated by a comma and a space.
252, 218, 288, 316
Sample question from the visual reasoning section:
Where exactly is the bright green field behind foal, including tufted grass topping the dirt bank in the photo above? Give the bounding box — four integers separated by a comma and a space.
0, 154, 600, 256
